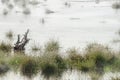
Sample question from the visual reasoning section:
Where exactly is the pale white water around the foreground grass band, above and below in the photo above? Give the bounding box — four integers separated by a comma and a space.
0, 0, 120, 80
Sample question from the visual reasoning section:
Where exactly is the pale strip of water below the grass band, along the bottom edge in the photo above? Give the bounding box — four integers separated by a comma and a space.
0, 70, 120, 80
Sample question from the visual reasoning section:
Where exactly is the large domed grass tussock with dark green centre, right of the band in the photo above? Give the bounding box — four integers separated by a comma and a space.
85, 44, 114, 73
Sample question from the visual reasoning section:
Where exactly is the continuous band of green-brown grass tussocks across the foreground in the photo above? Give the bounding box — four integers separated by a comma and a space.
0, 40, 120, 80
